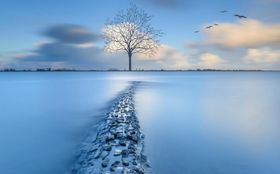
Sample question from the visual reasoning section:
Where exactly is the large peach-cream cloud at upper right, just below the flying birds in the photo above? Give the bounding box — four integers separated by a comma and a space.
206, 19, 280, 48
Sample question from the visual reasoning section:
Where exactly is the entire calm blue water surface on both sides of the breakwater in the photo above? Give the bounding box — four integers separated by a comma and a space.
0, 72, 280, 174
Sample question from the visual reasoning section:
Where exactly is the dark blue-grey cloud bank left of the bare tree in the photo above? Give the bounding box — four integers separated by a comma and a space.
11, 24, 122, 69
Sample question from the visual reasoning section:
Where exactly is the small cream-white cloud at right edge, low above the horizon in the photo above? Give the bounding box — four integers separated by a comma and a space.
245, 47, 280, 63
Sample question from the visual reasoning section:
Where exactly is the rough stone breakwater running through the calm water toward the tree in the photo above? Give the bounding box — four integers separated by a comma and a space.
71, 82, 151, 174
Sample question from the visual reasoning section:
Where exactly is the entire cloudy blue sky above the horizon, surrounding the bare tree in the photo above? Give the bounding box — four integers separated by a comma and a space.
0, 0, 280, 70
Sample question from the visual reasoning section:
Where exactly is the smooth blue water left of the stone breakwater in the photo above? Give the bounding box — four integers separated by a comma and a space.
0, 72, 127, 174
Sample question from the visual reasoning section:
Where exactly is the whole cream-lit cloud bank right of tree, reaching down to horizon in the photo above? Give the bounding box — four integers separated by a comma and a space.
186, 19, 280, 70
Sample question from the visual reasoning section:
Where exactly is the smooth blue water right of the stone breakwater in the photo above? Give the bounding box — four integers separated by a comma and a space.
137, 73, 280, 174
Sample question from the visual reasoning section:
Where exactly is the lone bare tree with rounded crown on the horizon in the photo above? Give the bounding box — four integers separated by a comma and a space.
103, 4, 162, 71
